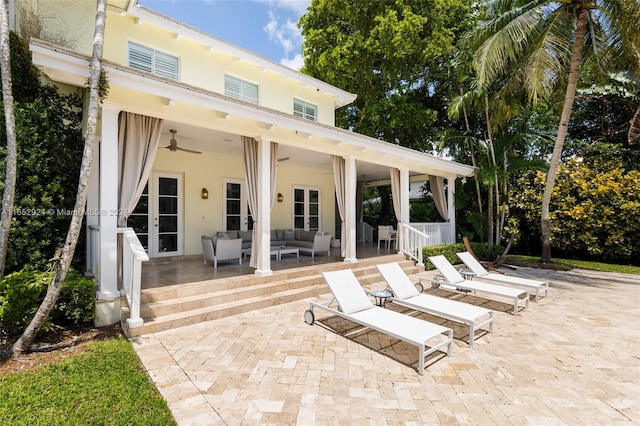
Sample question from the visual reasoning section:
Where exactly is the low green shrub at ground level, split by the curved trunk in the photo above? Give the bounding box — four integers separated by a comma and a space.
0, 267, 95, 340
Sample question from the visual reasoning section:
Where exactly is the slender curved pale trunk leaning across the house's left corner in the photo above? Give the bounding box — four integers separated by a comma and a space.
12, 0, 107, 354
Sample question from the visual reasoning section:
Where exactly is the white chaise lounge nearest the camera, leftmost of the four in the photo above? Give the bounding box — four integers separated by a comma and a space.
304, 269, 453, 375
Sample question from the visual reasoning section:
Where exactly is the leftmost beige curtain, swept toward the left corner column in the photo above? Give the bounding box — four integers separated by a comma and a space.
118, 112, 162, 226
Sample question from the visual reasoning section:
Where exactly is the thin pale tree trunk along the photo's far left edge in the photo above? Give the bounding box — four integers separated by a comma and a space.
0, 0, 18, 279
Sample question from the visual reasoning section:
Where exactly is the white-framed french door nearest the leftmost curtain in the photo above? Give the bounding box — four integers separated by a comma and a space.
127, 172, 184, 257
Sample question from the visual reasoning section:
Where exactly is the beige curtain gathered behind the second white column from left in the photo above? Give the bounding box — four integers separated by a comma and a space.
242, 136, 278, 268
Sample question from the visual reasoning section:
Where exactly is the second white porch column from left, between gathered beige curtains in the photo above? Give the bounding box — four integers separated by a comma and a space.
253, 136, 273, 276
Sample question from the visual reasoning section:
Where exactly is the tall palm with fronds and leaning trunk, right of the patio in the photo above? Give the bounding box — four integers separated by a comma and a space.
473, 0, 640, 262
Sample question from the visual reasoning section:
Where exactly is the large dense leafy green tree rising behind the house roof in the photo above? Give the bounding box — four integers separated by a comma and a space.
299, 0, 471, 150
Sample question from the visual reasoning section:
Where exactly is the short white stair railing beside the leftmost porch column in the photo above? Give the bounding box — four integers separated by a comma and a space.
118, 228, 149, 328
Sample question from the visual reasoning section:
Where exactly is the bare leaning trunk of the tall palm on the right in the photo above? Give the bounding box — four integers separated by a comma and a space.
540, 9, 587, 262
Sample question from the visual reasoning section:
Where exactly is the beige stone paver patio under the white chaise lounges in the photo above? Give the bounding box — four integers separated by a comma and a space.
132, 268, 640, 425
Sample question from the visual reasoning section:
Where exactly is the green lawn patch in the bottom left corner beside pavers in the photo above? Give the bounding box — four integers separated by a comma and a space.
0, 338, 176, 425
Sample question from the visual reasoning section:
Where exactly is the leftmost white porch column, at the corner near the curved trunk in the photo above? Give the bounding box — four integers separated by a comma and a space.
95, 103, 120, 299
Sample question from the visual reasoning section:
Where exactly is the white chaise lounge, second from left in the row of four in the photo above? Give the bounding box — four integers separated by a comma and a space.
376, 262, 493, 346
